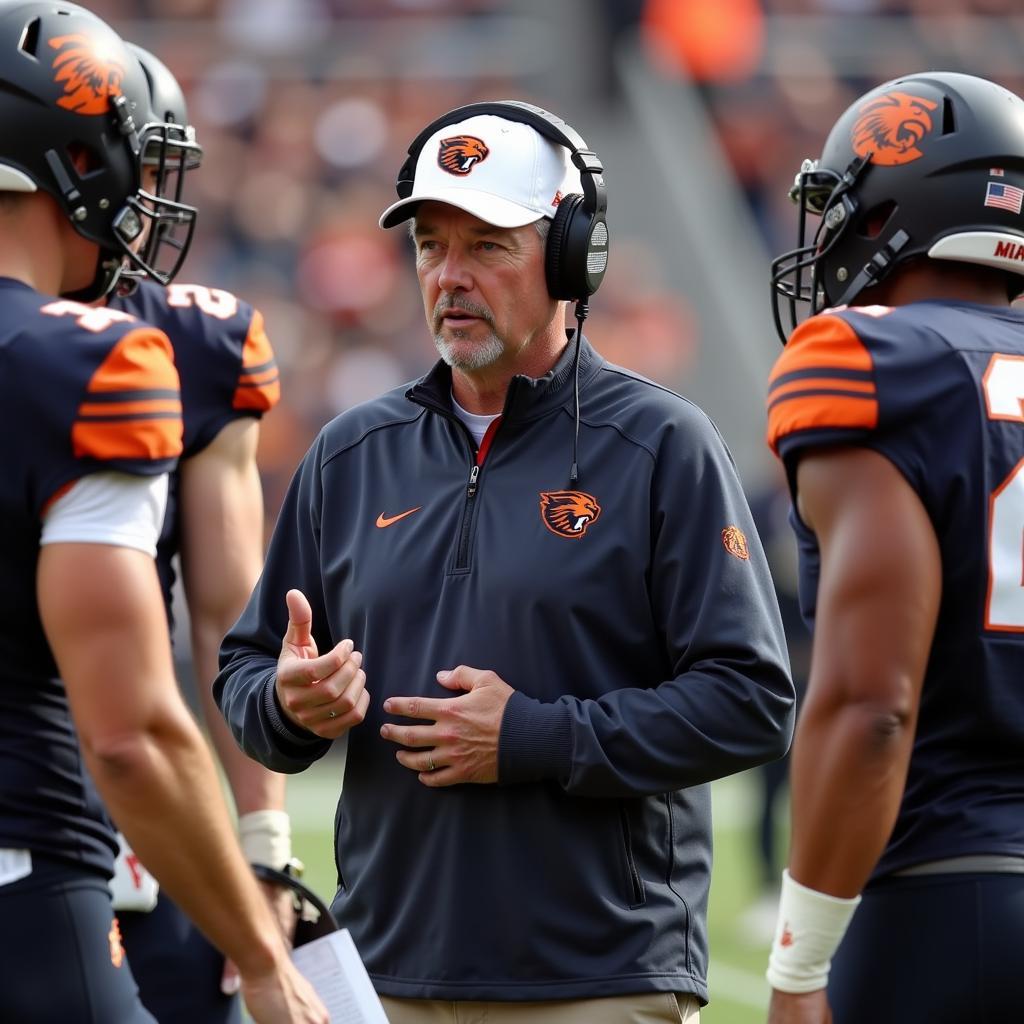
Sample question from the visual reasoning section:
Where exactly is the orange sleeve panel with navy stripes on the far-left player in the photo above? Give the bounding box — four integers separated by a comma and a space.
72, 327, 182, 462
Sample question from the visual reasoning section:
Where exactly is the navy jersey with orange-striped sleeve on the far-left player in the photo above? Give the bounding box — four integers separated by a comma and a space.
0, 279, 181, 873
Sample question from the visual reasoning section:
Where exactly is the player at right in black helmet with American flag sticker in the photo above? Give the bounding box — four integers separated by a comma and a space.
768, 73, 1024, 1024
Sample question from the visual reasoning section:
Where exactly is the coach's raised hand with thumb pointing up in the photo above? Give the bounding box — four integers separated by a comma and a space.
274, 590, 370, 739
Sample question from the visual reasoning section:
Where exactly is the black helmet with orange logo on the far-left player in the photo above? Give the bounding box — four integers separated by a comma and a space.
0, 0, 192, 301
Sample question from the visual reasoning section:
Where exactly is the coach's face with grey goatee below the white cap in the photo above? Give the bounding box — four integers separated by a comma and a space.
414, 202, 558, 374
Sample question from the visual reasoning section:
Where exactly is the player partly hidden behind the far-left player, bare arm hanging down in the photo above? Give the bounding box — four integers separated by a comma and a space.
104, 45, 299, 1024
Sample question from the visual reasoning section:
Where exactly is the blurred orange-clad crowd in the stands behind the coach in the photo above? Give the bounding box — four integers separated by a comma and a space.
83, 0, 1022, 523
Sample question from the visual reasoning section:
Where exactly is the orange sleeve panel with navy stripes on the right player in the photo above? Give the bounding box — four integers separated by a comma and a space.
767, 314, 879, 453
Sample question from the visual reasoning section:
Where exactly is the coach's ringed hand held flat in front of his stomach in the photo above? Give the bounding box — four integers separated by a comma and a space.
381, 665, 515, 786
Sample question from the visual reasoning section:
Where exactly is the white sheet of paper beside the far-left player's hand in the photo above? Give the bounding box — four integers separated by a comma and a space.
292, 928, 388, 1024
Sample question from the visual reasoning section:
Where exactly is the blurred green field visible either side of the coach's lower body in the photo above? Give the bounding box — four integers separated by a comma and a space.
288, 758, 768, 1024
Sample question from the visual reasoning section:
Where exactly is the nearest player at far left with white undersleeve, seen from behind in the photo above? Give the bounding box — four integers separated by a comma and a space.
0, 2, 327, 1024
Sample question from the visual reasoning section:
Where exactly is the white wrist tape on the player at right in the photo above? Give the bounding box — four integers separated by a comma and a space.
766, 869, 860, 992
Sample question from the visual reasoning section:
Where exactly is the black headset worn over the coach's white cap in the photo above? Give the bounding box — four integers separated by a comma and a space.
395, 99, 608, 303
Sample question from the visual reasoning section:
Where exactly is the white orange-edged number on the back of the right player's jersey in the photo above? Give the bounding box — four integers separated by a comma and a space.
981, 352, 1024, 633
